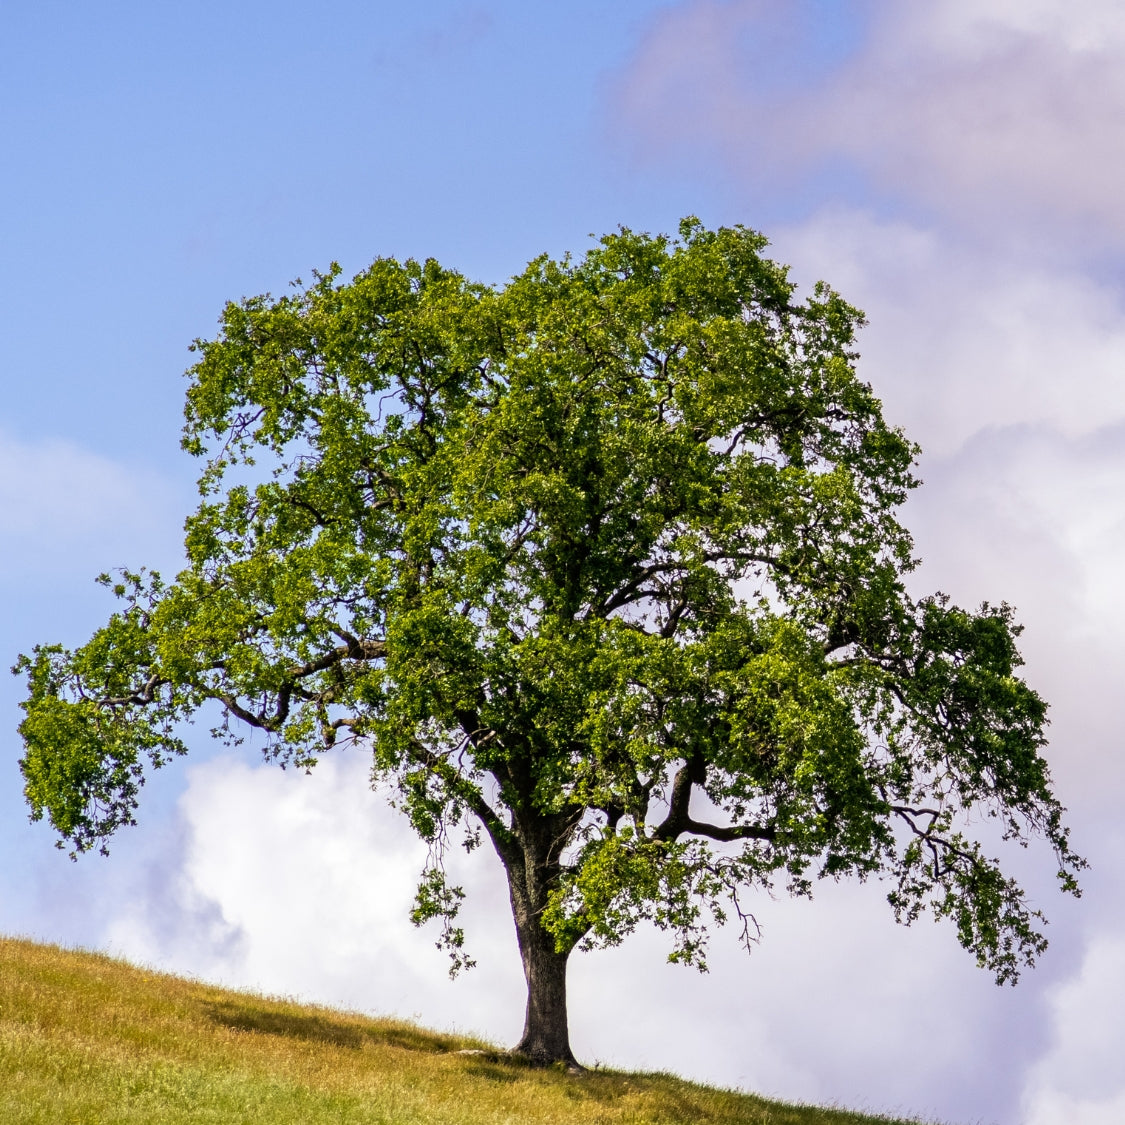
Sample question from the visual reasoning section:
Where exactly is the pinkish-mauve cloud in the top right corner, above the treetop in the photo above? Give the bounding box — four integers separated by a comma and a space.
613, 0, 1125, 242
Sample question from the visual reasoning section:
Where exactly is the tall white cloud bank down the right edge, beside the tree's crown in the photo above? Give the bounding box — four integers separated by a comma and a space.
775, 209, 1125, 804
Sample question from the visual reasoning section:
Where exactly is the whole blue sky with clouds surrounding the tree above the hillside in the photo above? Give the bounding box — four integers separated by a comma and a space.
0, 0, 1125, 1125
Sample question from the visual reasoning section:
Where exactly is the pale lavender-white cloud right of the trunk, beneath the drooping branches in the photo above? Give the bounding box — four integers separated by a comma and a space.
572, 883, 1040, 1121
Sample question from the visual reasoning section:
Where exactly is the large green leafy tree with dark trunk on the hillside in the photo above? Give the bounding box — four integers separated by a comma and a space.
17, 219, 1082, 1062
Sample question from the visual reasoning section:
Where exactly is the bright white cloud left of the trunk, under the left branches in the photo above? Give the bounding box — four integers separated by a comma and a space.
106, 753, 523, 1038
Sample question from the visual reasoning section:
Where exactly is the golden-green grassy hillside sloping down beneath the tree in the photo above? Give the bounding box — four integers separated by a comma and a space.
0, 939, 931, 1125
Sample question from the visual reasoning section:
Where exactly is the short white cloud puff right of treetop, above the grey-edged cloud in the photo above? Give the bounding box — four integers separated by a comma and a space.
771, 208, 1125, 455
